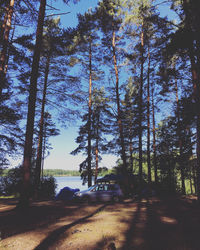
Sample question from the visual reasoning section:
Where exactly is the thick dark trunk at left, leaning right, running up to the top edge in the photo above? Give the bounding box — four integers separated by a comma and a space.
18, 0, 46, 208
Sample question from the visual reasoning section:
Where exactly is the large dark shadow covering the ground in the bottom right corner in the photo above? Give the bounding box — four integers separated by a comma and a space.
122, 197, 200, 250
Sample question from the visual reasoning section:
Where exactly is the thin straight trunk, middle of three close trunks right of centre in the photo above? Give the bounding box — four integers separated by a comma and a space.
147, 48, 151, 184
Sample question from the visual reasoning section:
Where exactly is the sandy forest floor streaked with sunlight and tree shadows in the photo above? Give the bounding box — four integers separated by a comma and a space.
0, 197, 200, 250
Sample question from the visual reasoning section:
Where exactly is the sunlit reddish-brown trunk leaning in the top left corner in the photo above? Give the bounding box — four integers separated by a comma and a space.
0, 0, 15, 97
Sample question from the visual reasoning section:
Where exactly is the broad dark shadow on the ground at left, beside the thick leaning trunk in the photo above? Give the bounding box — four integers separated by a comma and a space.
0, 201, 86, 239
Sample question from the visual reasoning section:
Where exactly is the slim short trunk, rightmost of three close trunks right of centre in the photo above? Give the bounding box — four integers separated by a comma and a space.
151, 83, 158, 184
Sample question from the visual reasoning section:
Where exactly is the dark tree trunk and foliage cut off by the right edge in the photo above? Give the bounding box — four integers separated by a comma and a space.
172, 0, 200, 200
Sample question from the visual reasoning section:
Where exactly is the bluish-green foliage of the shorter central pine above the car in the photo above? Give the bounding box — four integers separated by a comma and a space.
71, 88, 110, 183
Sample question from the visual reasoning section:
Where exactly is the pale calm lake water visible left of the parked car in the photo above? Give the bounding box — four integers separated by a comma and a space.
55, 176, 87, 193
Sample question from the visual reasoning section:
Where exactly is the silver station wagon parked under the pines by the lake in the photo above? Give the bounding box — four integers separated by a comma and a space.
74, 184, 123, 202
